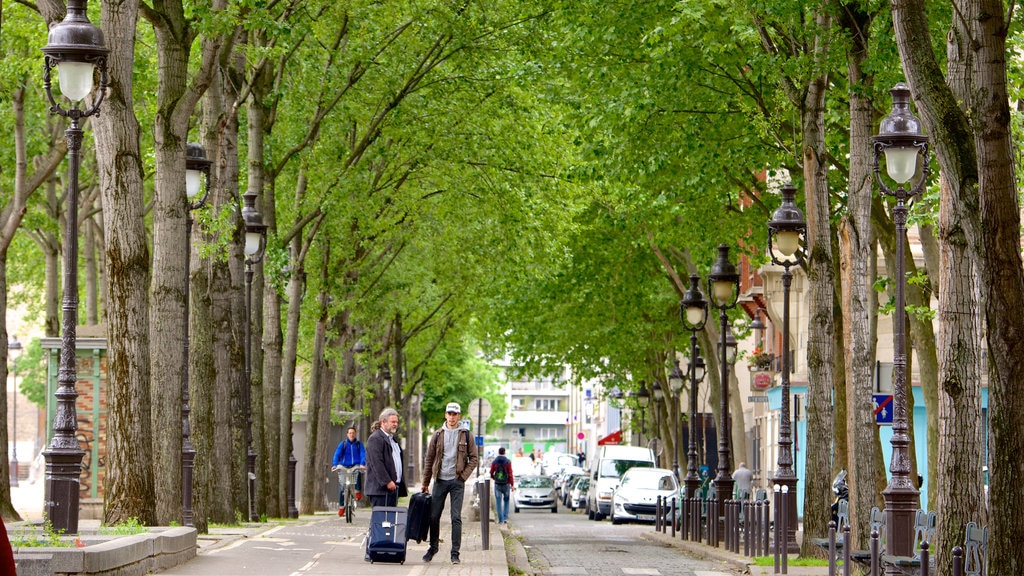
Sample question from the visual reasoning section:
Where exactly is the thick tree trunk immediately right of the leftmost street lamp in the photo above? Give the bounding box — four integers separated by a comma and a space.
92, 1, 155, 525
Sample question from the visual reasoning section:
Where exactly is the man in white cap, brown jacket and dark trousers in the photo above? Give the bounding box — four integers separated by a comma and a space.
423, 402, 480, 564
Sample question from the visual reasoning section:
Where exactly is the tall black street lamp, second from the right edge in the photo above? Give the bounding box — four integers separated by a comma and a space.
770, 182, 807, 551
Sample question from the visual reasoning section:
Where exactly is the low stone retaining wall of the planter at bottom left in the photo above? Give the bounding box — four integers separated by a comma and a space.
14, 528, 197, 576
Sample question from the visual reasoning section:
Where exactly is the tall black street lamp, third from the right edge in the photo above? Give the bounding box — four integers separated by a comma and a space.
708, 244, 739, 502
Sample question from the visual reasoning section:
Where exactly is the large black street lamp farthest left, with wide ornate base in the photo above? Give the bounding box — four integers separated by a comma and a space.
43, 0, 110, 534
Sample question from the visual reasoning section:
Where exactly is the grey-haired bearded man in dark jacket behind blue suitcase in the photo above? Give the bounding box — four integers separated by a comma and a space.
364, 408, 409, 506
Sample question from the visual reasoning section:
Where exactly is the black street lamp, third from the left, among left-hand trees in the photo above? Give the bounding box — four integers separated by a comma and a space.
242, 190, 267, 522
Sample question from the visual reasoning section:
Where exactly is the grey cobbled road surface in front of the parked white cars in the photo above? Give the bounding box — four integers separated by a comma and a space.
509, 507, 737, 576
